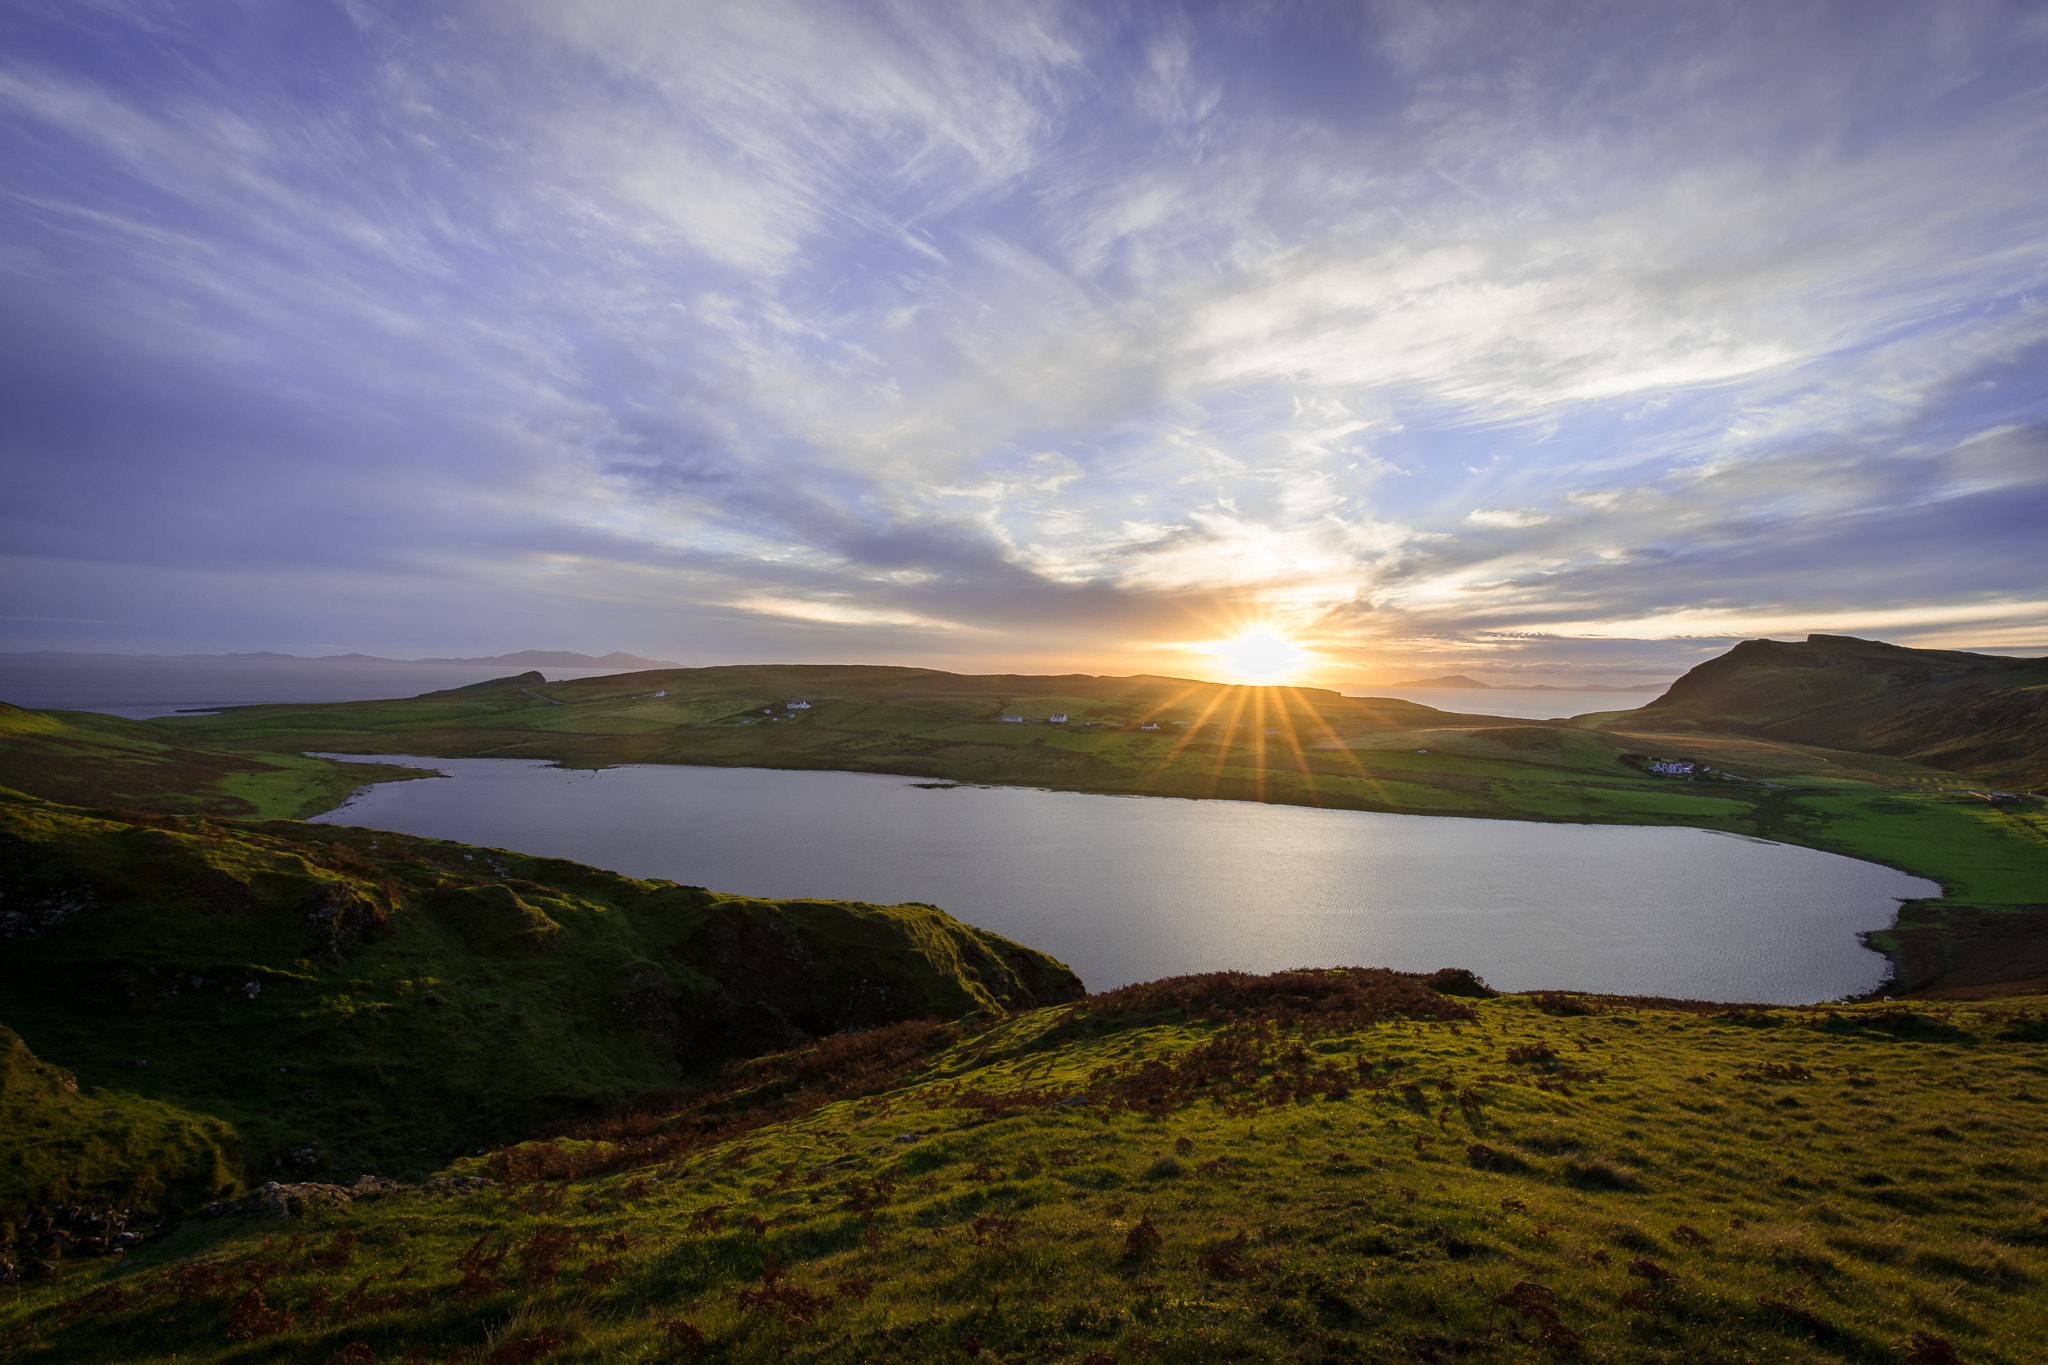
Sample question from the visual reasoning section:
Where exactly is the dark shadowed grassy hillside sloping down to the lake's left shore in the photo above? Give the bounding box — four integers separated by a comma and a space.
0, 792, 1081, 1218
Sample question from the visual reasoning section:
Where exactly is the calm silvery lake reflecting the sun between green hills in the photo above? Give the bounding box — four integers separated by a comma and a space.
317, 755, 1939, 1005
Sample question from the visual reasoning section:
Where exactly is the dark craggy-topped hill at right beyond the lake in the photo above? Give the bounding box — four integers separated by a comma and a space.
1626, 634, 2048, 786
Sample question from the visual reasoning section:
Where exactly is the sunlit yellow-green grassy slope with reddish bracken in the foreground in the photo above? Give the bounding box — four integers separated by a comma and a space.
0, 972, 2048, 1365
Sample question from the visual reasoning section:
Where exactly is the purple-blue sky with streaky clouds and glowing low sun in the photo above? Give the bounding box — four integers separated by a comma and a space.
0, 0, 2048, 686
